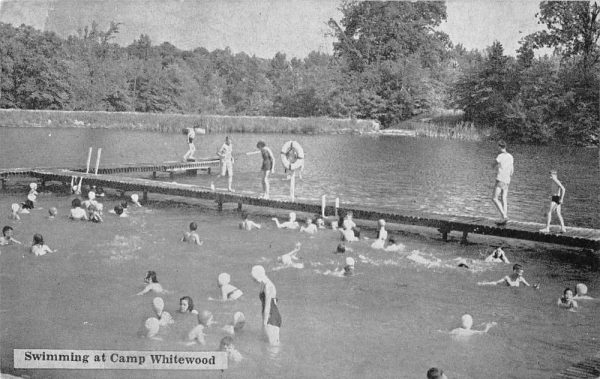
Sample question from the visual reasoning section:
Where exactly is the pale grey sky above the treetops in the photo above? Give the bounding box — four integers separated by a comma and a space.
0, 0, 541, 58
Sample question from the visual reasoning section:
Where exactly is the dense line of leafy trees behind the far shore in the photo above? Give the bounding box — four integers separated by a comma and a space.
0, 0, 600, 145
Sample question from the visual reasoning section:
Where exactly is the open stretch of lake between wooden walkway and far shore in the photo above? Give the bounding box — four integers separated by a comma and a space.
0, 128, 600, 228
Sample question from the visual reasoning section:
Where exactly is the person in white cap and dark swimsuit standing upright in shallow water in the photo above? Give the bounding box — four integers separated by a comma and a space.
251, 266, 281, 346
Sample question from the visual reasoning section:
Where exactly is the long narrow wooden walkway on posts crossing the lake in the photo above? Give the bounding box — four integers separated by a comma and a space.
0, 168, 600, 260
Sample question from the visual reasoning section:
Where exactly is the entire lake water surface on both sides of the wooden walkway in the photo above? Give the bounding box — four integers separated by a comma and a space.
0, 128, 600, 379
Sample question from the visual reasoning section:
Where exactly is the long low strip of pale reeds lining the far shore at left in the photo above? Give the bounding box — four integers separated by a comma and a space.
0, 109, 379, 134
